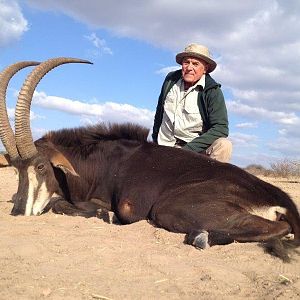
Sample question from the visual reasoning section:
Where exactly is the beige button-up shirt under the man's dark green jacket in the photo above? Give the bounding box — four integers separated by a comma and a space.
158, 74, 205, 147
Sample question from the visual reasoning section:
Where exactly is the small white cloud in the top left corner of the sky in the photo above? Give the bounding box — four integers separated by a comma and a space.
0, 0, 28, 47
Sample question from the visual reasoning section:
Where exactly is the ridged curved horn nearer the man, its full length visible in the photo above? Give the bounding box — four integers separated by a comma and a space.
15, 57, 92, 159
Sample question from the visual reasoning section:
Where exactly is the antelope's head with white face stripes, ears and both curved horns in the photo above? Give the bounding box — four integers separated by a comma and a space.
0, 57, 91, 216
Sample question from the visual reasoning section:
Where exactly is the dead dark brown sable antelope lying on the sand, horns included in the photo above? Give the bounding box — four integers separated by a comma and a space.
0, 58, 300, 259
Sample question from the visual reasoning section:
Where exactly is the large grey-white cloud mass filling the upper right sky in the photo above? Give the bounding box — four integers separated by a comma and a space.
27, 0, 300, 114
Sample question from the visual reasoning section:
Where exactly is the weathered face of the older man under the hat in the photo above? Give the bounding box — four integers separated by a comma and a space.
182, 57, 207, 85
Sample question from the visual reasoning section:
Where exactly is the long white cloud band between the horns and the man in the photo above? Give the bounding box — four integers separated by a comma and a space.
33, 91, 154, 128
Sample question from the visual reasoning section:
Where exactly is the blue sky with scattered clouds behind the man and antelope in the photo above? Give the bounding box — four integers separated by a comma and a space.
0, 0, 300, 167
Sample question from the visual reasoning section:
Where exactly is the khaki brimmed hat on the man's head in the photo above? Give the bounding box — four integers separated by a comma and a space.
176, 44, 217, 73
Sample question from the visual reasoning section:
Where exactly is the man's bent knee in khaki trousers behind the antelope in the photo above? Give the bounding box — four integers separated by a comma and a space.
206, 138, 232, 162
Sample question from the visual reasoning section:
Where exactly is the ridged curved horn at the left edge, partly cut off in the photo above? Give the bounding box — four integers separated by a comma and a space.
0, 61, 39, 160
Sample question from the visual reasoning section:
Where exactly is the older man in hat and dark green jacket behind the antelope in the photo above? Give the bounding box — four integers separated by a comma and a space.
152, 44, 232, 162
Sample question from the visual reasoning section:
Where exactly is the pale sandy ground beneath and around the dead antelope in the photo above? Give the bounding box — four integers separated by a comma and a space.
0, 168, 300, 300
